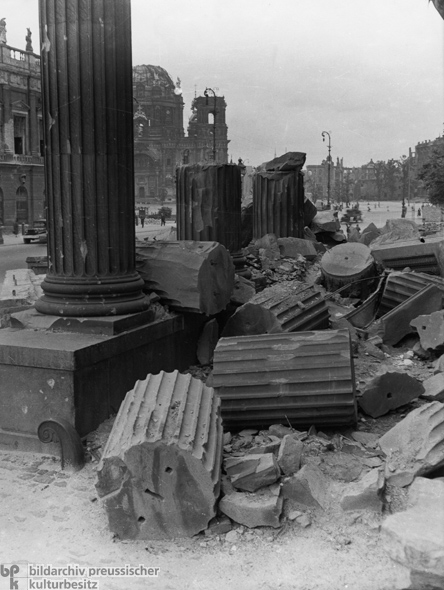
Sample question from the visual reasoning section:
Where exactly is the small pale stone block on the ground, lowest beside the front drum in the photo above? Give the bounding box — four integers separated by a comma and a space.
219, 488, 283, 528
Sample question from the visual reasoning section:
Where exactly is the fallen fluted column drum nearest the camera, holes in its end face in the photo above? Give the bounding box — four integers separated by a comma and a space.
96, 371, 223, 539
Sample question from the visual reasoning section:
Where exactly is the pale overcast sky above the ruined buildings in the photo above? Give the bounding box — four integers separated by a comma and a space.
0, 0, 444, 166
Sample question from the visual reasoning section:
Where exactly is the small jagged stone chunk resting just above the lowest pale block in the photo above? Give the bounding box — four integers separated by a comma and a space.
224, 453, 280, 492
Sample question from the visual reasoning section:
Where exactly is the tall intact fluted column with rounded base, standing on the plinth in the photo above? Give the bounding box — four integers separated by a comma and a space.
36, 0, 148, 316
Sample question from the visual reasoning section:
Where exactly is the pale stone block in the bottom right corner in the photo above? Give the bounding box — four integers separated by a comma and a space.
381, 477, 444, 590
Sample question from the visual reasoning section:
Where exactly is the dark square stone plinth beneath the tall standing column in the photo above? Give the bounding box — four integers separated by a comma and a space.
0, 316, 201, 453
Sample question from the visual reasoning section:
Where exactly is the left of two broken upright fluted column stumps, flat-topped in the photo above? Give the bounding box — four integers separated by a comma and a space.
176, 164, 251, 276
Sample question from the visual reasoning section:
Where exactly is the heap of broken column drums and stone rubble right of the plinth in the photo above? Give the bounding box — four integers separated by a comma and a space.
91, 206, 444, 590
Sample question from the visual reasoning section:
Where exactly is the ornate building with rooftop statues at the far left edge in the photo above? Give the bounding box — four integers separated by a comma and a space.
0, 28, 45, 227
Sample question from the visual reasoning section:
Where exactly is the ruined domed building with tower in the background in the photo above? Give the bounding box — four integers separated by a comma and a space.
133, 65, 229, 203
